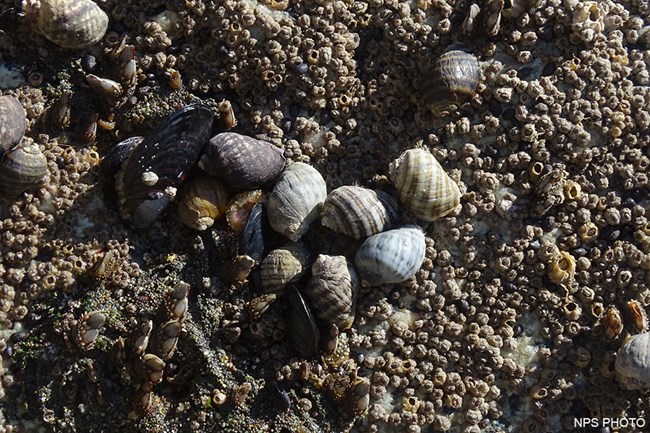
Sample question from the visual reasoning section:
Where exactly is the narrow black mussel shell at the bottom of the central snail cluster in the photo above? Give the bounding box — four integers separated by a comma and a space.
287, 286, 320, 358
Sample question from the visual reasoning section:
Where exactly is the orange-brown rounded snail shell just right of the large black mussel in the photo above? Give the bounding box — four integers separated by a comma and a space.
176, 174, 230, 231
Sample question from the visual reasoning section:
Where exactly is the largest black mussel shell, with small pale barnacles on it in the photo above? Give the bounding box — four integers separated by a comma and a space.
116, 104, 213, 228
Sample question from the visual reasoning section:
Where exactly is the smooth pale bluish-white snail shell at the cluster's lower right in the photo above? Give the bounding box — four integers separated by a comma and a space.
354, 224, 426, 286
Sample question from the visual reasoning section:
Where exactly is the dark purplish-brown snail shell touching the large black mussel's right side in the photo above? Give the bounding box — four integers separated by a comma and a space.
199, 132, 287, 191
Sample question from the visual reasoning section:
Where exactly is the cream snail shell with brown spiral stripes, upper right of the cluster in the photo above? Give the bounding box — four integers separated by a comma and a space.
389, 149, 460, 221
